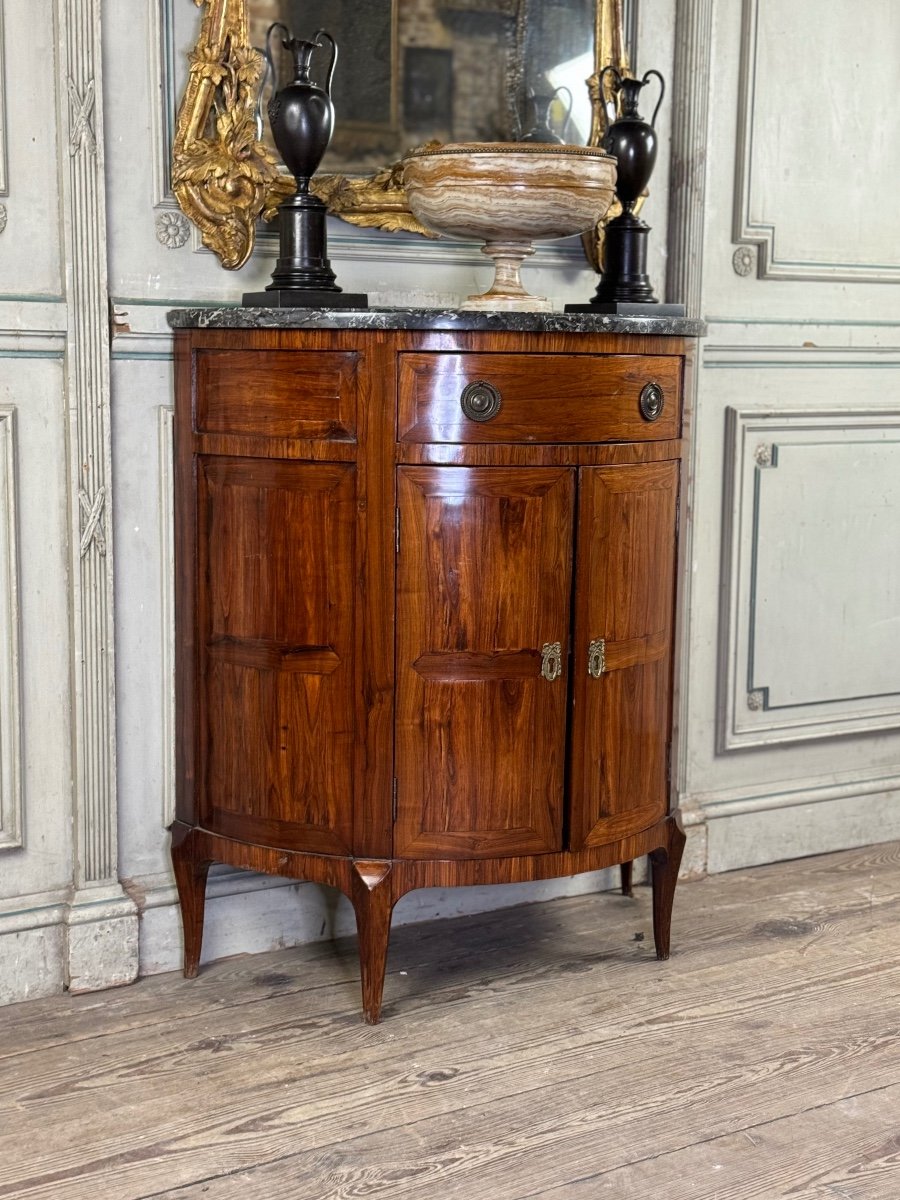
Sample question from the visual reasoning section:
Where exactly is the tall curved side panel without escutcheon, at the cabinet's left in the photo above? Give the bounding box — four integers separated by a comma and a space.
197, 457, 355, 853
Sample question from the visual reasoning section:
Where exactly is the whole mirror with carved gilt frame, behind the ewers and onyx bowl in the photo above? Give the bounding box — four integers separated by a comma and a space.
172, 0, 637, 270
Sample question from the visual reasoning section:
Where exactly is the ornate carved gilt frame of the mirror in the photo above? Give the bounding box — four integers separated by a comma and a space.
172, 0, 629, 270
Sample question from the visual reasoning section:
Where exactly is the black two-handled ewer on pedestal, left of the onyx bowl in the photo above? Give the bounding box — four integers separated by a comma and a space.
244, 22, 368, 308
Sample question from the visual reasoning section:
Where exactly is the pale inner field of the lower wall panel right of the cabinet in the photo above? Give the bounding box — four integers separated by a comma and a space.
750, 441, 900, 709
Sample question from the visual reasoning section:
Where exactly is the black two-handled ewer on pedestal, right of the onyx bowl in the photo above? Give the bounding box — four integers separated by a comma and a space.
565, 67, 684, 316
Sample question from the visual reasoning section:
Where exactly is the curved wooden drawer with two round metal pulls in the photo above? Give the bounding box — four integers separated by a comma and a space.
398, 354, 682, 443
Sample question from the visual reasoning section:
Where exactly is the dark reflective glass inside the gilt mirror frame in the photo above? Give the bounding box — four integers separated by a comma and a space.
247, 0, 595, 175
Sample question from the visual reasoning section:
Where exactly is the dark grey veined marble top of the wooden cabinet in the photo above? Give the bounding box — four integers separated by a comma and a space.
167, 307, 706, 337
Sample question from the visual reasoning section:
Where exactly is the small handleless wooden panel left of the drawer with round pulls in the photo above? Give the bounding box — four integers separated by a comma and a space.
194, 350, 356, 442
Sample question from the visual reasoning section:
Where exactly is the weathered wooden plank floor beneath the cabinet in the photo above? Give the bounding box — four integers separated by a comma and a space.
0, 845, 900, 1200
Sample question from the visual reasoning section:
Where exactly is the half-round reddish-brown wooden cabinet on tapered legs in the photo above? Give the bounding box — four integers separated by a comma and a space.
169, 308, 701, 1024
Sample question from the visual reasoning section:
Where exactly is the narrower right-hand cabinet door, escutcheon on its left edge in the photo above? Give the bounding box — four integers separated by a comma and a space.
569, 462, 678, 850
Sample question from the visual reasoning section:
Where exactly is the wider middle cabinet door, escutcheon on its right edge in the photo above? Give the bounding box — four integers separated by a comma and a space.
394, 467, 575, 858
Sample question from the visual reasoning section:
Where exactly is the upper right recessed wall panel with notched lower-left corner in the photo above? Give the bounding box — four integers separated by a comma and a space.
734, 0, 900, 282
